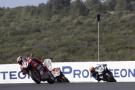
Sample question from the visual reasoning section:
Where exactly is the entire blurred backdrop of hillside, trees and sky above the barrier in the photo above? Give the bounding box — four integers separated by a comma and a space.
0, 0, 135, 64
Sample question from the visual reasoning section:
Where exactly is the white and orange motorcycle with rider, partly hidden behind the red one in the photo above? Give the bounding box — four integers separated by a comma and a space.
43, 59, 69, 82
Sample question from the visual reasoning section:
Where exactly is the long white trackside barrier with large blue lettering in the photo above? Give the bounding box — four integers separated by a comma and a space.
0, 61, 135, 84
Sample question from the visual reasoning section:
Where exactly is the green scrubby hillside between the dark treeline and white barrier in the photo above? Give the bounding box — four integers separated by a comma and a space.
0, 6, 135, 64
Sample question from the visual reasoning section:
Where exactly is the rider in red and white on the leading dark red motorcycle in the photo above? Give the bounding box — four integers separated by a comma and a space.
16, 56, 43, 75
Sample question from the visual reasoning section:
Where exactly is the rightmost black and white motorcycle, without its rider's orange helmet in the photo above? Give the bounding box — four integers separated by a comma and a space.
92, 64, 116, 82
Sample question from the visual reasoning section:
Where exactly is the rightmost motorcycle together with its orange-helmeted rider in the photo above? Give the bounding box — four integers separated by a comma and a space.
90, 64, 116, 82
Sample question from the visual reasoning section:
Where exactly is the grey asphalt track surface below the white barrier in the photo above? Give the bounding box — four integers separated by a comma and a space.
0, 82, 135, 90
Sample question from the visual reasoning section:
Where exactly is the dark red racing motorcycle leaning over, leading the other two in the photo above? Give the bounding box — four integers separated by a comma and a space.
23, 60, 55, 84
